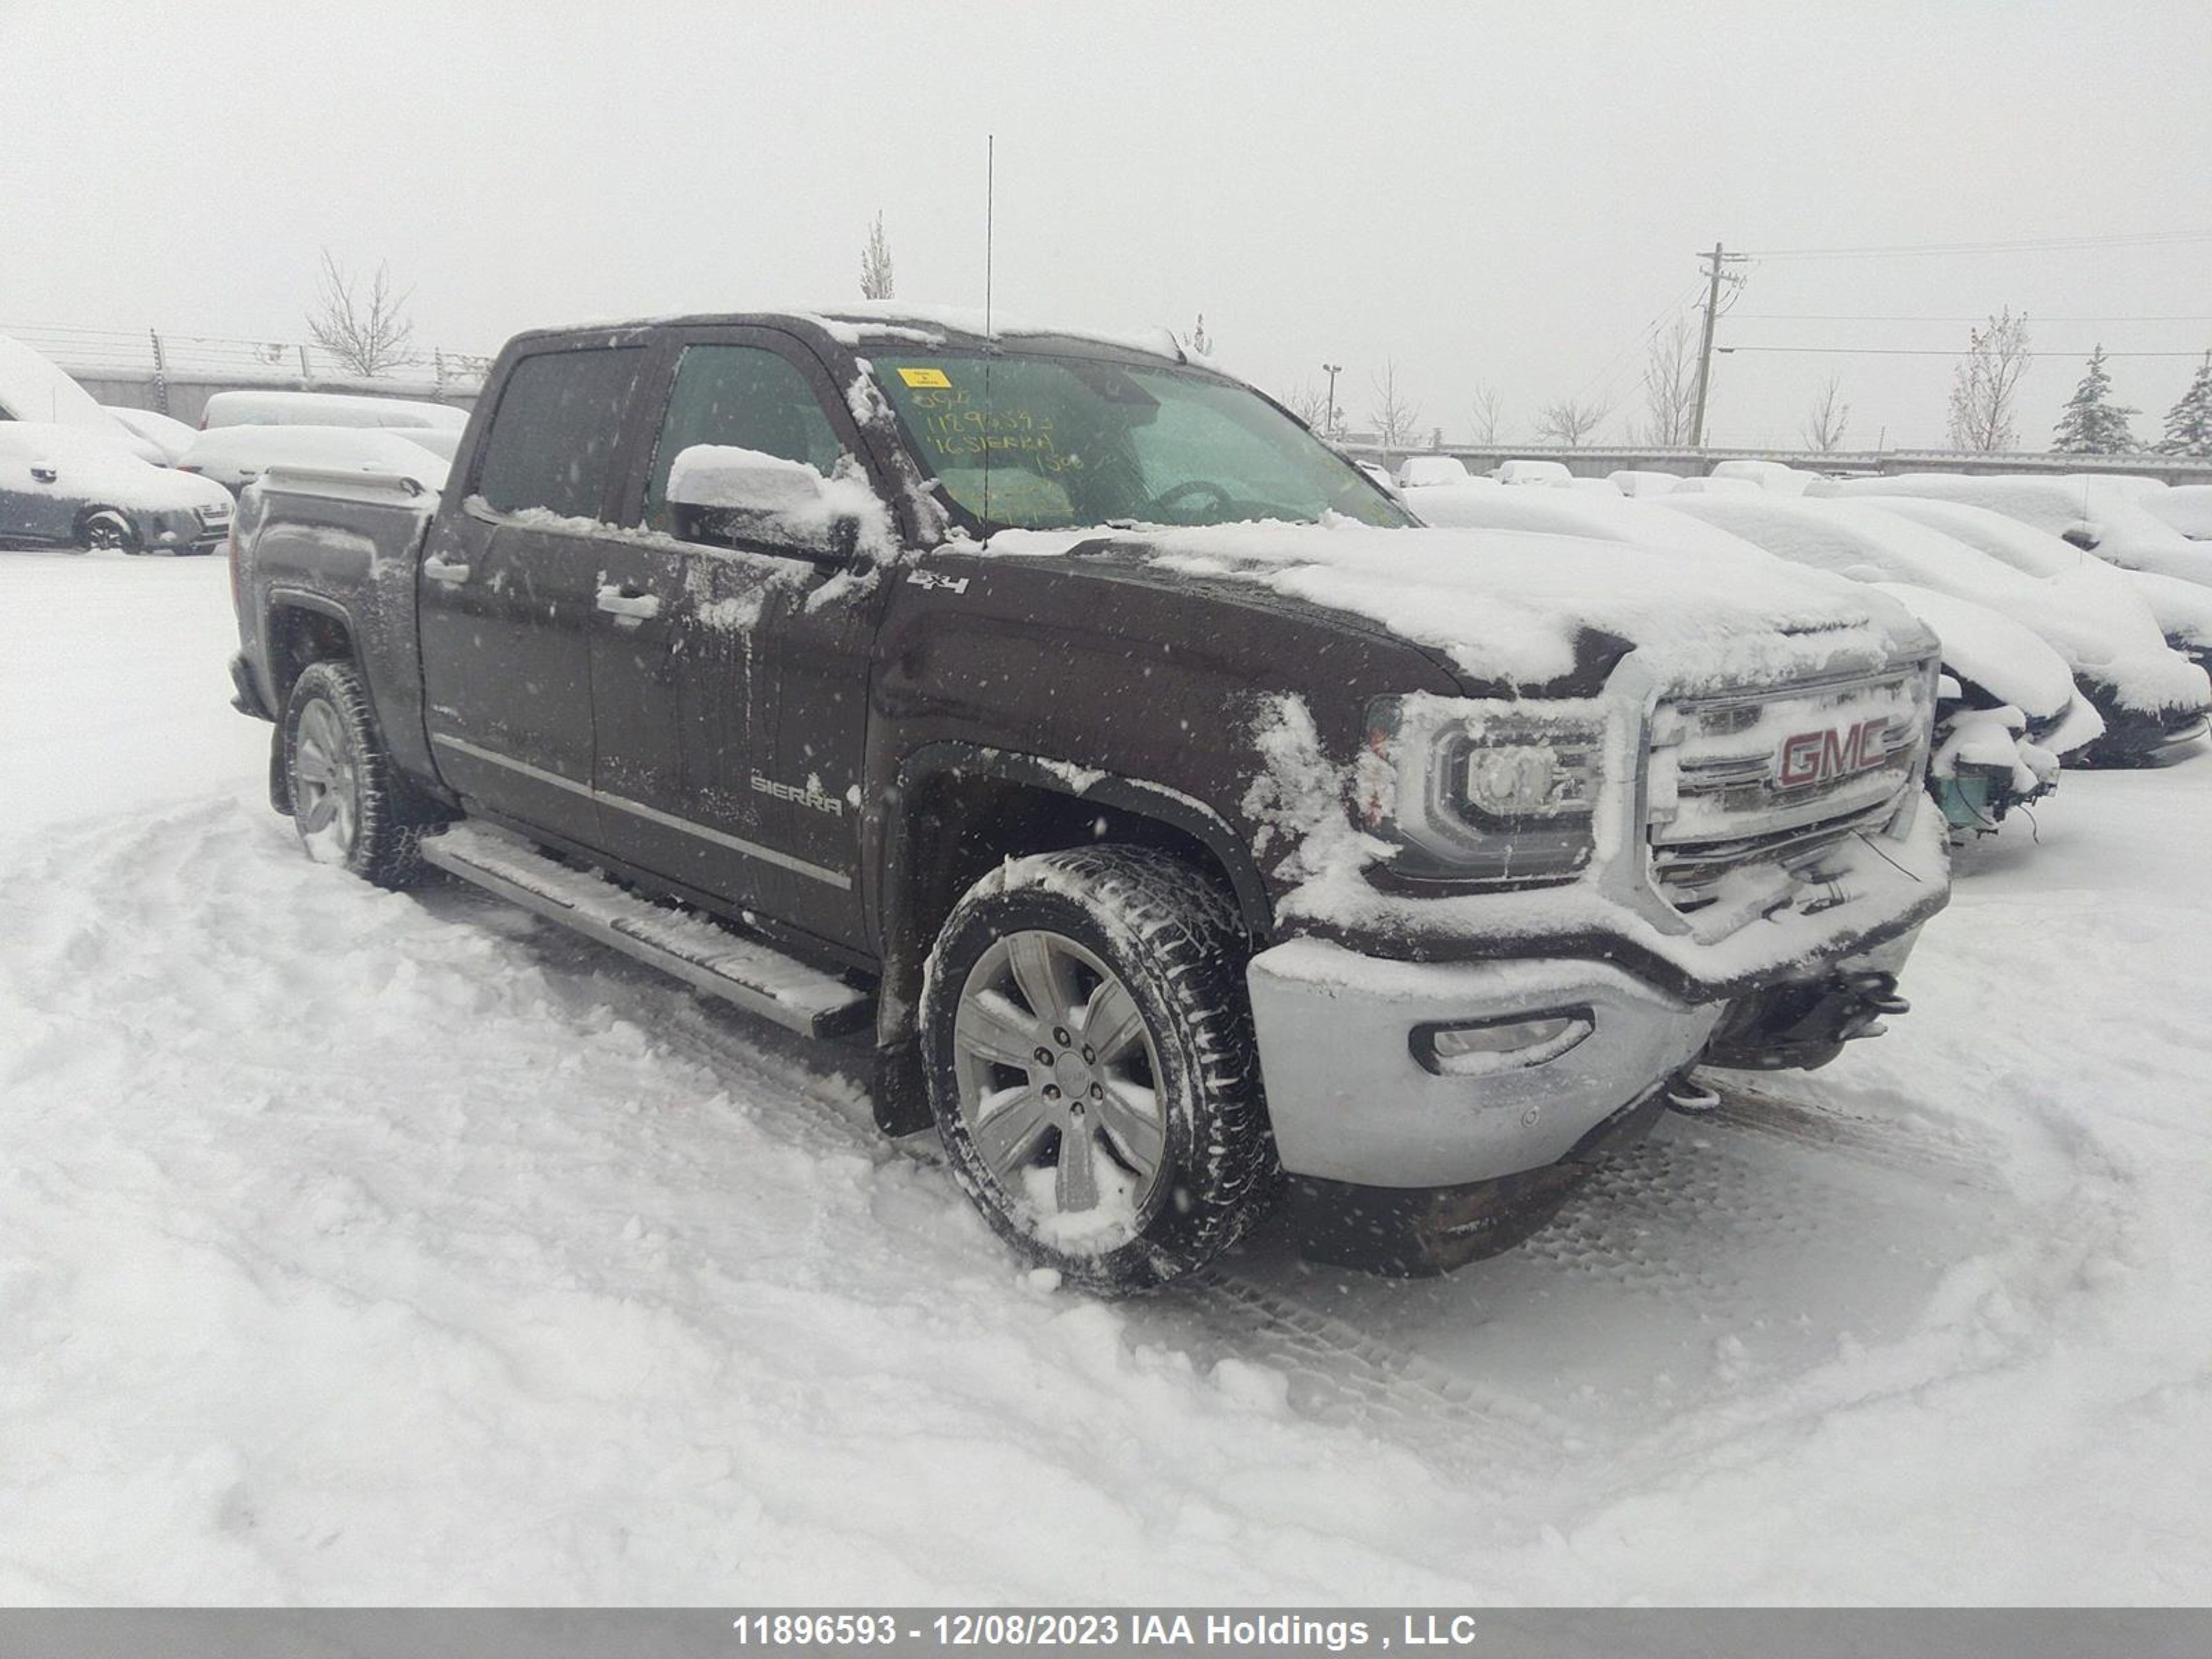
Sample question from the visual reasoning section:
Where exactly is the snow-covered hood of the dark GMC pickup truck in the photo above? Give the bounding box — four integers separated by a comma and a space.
988, 518, 1933, 690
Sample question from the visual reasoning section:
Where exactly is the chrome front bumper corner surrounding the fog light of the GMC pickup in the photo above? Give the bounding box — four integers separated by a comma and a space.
1248, 940, 1725, 1188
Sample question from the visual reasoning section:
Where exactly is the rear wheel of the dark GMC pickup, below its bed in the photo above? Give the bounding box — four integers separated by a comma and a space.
283, 662, 422, 887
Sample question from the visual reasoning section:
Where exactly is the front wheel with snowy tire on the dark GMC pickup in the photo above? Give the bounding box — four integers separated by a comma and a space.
922, 847, 1281, 1290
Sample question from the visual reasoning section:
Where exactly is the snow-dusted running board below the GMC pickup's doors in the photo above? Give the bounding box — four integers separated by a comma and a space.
422, 823, 874, 1038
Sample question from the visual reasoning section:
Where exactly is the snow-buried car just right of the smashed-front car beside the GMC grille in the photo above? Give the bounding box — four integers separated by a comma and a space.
1851, 496, 2212, 765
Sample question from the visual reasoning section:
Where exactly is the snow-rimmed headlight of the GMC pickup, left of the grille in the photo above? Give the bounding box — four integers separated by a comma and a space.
1362, 697, 1606, 883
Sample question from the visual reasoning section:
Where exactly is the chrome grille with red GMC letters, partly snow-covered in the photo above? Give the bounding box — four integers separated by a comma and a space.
1646, 664, 1933, 911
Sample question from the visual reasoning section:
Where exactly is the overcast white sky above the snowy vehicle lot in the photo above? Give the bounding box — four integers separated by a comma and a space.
12, 0, 2212, 447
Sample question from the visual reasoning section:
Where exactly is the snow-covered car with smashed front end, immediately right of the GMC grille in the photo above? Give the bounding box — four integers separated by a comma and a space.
1650, 491, 2103, 830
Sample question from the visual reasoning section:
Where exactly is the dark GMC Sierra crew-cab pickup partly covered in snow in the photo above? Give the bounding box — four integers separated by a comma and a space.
232, 308, 1947, 1287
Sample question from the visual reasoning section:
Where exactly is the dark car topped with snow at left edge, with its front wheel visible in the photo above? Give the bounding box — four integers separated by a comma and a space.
0, 420, 230, 553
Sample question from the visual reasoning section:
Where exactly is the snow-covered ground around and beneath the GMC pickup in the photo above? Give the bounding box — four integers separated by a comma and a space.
0, 553, 2212, 1604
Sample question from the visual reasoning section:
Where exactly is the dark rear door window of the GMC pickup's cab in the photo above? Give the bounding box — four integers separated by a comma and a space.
476, 345, 646, 518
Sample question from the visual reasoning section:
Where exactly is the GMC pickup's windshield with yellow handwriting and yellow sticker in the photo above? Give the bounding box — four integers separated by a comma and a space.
876, 352, 1414, 533
